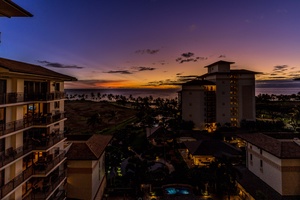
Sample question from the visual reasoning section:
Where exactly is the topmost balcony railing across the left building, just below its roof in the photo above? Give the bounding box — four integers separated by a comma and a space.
0, 92, 65, 104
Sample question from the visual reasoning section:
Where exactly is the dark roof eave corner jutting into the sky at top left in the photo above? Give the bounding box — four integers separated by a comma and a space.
0, 0, 33, 17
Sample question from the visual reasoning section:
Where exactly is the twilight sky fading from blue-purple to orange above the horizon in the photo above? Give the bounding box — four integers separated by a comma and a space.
0, 0, 300, 88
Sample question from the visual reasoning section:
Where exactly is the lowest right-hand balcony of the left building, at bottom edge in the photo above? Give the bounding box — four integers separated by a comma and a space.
23, 172, 66, 200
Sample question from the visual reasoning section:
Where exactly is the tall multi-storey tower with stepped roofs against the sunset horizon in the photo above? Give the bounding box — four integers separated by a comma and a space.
180, 61, 257, 131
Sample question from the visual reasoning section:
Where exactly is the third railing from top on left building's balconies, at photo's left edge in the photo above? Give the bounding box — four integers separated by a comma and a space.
0, 145, 33, 168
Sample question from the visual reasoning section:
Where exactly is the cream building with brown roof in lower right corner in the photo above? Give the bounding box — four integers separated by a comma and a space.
239, 133, 300, 200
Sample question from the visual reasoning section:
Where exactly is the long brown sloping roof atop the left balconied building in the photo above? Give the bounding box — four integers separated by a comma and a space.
0, 56, 77, 81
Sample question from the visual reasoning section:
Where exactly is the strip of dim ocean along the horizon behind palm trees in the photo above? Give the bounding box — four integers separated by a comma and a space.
65, 80, 300, 100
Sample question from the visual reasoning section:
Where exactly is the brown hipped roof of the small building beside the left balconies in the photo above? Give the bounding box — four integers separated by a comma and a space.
67, 134, 112, 160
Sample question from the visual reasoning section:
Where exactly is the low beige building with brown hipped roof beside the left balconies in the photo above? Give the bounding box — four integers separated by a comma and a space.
67, 134, 112, 199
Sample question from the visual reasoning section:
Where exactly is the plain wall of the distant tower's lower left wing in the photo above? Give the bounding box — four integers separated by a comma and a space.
181, 86, 204, 129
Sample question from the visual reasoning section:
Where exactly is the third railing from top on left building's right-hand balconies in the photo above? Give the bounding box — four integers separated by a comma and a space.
33, 134, 65, 150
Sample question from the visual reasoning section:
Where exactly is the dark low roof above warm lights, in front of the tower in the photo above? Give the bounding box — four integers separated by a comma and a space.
184, 139, 241, 156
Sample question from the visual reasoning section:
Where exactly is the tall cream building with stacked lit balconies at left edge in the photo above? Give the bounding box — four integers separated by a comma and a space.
0, 57, 76, 199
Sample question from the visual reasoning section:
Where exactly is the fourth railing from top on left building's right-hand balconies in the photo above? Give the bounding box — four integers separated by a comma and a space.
33, 151, 66, 175
